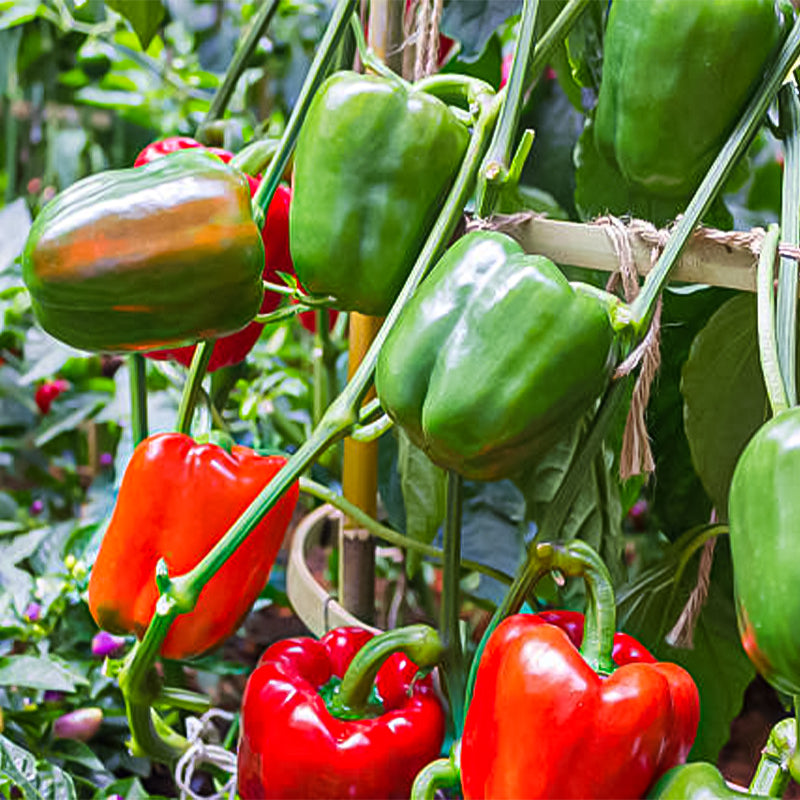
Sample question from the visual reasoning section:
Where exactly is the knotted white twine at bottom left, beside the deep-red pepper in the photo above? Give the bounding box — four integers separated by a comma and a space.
175, 708, 236, 800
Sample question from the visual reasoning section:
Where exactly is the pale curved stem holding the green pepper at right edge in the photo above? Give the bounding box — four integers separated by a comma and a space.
757, 224, 789, 414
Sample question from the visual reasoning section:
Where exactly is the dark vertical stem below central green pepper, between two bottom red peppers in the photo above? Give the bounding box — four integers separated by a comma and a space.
439, 470, 466, 739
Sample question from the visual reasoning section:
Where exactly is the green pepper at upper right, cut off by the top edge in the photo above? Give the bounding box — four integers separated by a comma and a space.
594, 0, 781, 197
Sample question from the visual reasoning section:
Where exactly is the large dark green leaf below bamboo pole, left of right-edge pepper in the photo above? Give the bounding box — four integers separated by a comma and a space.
681, 294, 767, 515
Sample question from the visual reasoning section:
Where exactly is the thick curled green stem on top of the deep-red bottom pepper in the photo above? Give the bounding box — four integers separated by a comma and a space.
330, 625, 445, 715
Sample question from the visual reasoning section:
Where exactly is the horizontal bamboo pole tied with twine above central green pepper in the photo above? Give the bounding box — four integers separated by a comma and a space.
490, 216, 763, 292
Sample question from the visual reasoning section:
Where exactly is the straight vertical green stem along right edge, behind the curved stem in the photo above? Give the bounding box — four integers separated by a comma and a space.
777, 83, 800, 406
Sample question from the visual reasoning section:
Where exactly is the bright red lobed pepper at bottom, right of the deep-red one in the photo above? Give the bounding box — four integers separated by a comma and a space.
461, 614, 700, 800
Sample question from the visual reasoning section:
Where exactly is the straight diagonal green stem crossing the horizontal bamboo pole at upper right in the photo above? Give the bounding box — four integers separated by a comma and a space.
631, 18, 800, 332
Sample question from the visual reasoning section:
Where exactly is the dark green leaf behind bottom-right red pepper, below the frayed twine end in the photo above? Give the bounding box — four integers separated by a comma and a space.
617, 535, 755, 762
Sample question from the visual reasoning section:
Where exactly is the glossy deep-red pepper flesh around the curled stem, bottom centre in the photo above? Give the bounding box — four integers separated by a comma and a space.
238, 627, 445, 800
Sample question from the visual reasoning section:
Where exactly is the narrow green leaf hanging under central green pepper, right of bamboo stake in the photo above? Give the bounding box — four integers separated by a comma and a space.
397, 429, 447, 576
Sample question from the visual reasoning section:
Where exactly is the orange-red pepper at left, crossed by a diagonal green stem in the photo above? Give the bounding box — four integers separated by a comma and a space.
89, 433, 298, 658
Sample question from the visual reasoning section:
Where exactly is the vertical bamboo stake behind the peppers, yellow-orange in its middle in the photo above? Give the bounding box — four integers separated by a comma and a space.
339, 0, 405, 622
